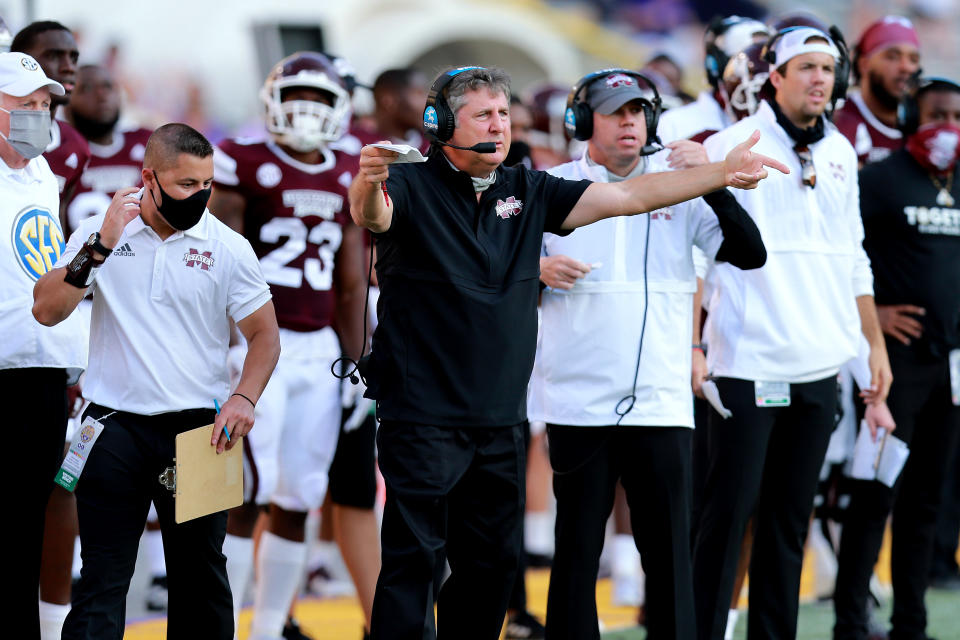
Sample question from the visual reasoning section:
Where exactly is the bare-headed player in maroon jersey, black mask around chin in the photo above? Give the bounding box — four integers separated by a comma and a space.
64, 65, 150, 234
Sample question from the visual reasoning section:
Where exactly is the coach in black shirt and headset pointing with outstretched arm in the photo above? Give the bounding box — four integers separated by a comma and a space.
350, 67, 789, 640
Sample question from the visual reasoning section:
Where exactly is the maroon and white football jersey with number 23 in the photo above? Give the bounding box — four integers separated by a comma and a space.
213, 140, 359, 331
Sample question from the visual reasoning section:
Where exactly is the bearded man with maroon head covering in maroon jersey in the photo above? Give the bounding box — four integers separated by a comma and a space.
833, 16, 920, 166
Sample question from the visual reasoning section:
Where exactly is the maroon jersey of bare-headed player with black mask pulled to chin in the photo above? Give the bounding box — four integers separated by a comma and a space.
64, 129, 152, 237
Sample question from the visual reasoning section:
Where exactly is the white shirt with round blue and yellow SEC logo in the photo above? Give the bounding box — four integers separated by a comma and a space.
0, 156, 87, 369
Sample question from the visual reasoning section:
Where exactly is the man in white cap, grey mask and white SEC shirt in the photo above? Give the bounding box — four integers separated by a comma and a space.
0, 52, 87, 638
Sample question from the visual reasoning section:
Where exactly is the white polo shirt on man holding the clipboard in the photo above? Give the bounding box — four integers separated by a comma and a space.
58, 211, 270, 415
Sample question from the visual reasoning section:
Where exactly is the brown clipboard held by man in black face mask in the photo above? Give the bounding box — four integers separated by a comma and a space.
167, 424, 243, 524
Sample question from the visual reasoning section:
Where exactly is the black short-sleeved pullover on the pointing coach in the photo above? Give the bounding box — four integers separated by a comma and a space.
367, 152, 590, 426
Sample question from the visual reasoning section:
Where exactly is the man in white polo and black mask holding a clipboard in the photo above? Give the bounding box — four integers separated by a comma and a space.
33, 124, 280, 640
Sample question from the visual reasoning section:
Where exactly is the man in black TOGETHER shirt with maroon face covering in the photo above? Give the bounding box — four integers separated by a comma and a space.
834, 78, 960, 640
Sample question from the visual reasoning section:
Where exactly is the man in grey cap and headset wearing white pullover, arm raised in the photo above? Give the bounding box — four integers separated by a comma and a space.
530, 70, 766, 640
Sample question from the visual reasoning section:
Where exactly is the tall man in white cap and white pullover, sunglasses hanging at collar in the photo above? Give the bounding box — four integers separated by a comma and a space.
693, 27, 890, 640
